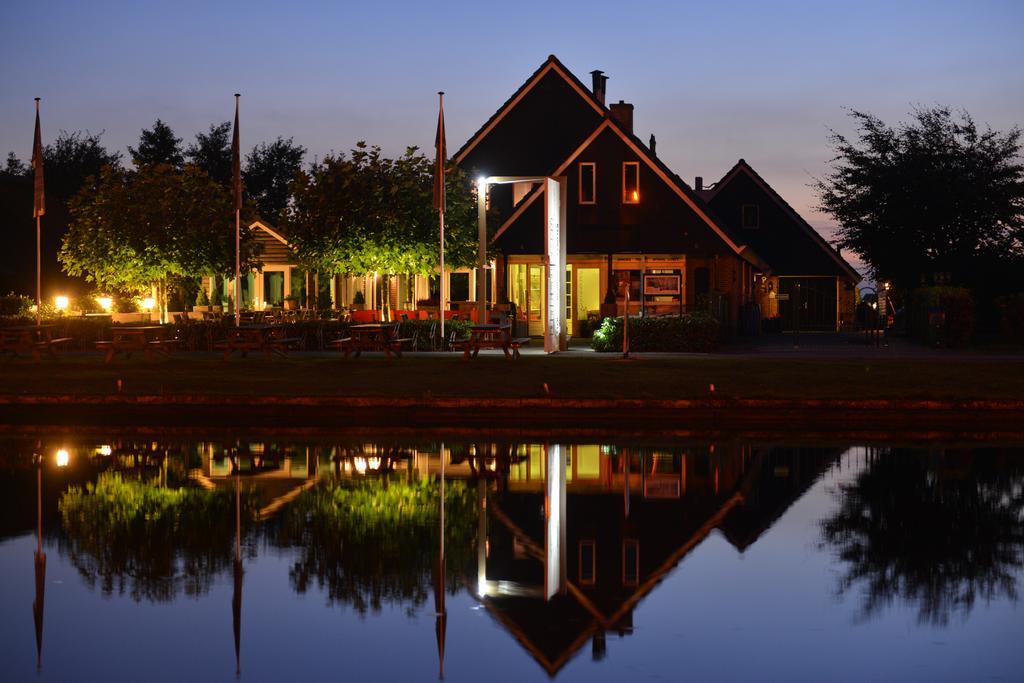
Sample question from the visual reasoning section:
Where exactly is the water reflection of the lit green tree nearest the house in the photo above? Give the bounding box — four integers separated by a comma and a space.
275, 478, 476, 613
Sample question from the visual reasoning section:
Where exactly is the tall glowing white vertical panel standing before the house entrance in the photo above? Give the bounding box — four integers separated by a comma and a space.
544, 178, 566, 353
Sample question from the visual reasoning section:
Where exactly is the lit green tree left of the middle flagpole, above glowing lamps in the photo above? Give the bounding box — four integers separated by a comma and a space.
59, 164, 258, 301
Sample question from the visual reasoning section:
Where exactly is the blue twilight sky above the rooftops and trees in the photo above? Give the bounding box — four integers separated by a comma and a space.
0, 0, 1024, 274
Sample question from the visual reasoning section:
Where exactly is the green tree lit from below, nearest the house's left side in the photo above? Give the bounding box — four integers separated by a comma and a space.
284, 141, 477, 275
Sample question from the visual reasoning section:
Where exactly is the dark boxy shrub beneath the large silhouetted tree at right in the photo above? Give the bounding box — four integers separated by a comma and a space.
907, 287, 974, 348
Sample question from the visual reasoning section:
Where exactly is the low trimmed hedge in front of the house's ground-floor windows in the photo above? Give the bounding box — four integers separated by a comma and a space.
591, 312, 721, 352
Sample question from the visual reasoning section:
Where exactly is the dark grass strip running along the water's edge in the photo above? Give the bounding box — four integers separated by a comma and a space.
0, 354, 1024, 399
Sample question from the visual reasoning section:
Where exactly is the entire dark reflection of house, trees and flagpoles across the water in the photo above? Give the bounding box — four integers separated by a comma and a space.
0, 440, 1024, 677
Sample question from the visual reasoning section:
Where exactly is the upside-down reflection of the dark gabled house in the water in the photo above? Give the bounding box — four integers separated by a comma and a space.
478, 445, 839, 675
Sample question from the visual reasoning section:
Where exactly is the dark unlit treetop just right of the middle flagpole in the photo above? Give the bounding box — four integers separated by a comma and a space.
242, 137, 306, 225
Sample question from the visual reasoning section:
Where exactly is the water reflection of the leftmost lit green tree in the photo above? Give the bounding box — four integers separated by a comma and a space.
59, 473, 255, 601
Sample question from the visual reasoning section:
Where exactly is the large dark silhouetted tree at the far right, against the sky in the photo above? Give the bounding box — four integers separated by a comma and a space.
815, 106, 1024, 288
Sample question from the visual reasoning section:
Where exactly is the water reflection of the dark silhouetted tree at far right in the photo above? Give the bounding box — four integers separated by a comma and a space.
821, 452, 1024, 625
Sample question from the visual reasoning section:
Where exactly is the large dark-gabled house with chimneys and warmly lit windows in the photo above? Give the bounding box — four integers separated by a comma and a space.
454, 55, 855, 335
